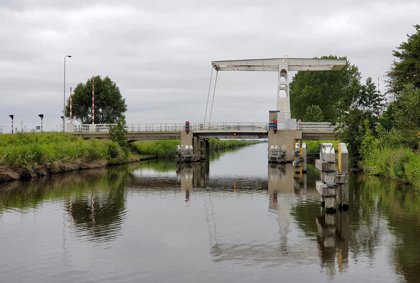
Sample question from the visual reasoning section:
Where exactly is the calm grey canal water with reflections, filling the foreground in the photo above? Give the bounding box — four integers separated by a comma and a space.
0, 144, 420, 283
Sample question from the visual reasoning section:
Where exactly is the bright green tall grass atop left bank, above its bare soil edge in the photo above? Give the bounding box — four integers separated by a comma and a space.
0, 133, 127, 169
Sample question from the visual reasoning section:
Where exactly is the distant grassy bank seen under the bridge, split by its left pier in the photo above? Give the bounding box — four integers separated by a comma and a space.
131, 139, 255, 159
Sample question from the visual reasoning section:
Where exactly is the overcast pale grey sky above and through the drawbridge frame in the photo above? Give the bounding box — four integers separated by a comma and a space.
0, 0, 420, 133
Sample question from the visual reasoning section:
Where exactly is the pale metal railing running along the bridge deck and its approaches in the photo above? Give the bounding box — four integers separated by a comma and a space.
75, 122, 334, 133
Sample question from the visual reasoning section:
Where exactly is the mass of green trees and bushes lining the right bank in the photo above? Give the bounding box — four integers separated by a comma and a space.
356, 25, 420, 188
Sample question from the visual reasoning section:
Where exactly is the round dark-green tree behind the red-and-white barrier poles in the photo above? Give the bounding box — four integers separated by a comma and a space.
66, 76, 127, 124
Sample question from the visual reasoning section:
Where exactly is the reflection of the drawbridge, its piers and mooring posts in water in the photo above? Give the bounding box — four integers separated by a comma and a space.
129, 162, 351, 276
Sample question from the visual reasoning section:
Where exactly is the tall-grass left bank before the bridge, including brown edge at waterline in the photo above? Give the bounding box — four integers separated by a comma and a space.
0, 133, 140, 182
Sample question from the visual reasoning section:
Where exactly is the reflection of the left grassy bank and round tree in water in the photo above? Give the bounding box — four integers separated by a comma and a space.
0, 167, 129, 245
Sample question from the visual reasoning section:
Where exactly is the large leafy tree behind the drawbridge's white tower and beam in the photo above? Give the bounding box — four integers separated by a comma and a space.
290, 56, 360, 122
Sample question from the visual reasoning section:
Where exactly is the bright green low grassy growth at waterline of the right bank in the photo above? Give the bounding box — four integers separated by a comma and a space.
362, 147, 420, 189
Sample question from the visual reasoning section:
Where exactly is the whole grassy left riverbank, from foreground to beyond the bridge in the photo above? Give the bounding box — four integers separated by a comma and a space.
0, 133, 255, 183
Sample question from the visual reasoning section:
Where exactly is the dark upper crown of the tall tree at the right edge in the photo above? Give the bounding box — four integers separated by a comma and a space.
388, 25, 420, 97
